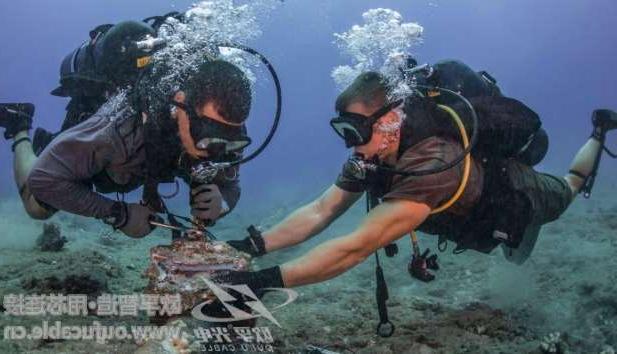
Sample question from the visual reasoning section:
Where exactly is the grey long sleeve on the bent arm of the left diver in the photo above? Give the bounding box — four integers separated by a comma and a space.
27, 117, 123, 218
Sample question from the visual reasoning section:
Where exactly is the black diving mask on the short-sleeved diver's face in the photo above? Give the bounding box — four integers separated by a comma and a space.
330, 100, 403, 148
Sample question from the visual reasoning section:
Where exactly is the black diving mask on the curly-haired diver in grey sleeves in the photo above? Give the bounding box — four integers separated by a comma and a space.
171, 100, 251, 159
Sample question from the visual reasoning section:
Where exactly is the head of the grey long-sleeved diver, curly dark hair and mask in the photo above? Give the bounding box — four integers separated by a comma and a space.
172, 60, 251, 159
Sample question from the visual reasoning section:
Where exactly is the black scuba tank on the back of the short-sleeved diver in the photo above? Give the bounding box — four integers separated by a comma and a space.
408, 60, 548, 166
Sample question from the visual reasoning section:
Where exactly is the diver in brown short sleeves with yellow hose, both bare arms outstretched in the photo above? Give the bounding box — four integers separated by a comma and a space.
215, 61, 617, 332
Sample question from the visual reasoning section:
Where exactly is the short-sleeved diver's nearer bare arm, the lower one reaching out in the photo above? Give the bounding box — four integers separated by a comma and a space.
281, 199, 430, 287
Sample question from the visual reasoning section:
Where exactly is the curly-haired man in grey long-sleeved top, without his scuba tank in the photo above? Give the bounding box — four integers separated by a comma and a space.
0, 59, 251, 237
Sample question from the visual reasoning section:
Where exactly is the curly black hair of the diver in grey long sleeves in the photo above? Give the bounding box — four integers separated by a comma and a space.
185, 59, 252, 124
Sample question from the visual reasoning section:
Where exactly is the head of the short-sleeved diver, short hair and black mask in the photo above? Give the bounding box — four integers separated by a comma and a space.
330, 72, 402, 161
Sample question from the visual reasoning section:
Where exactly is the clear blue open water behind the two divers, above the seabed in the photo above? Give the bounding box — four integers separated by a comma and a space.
0, 0, 617, 210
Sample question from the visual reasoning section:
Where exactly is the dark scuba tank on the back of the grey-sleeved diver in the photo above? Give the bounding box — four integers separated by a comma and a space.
32, 17, 173, 155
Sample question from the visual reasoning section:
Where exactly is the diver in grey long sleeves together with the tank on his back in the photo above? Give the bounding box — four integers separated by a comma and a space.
0, 18, 251, 237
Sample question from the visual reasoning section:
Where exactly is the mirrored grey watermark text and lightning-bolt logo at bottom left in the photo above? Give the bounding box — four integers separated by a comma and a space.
2, 286, 298, 352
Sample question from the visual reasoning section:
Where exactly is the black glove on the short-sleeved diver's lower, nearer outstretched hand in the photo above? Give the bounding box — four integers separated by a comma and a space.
211, 266, 285, 297
